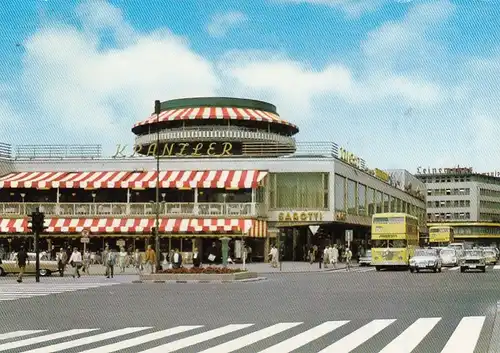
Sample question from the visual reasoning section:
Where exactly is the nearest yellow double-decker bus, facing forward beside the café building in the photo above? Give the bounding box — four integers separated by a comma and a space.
371, 213, 419, 271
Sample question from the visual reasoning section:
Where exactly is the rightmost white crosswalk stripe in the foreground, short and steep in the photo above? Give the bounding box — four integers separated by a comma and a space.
441, 316, 486, 353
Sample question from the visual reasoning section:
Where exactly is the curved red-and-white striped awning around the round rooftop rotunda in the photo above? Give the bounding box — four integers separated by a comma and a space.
134, 107, 297, 128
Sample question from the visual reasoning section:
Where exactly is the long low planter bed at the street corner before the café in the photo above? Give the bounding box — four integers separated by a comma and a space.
141, 272, 258, 282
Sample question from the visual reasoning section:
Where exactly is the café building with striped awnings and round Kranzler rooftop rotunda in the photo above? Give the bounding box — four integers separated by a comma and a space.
0, 97, 426, 261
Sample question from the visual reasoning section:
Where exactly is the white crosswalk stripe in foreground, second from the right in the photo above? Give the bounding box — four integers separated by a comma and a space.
379, 317, 441, 353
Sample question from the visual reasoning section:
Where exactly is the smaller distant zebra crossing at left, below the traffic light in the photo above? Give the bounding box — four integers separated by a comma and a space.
0, 280, 117, 302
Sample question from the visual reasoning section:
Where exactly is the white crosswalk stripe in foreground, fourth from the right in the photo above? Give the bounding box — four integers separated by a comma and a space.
259, 321, 349, 353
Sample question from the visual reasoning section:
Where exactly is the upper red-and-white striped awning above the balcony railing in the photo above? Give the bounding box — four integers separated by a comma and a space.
0, 170, 267, 189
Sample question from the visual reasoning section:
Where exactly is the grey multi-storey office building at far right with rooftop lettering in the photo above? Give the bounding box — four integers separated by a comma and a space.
416, 167, 500, 245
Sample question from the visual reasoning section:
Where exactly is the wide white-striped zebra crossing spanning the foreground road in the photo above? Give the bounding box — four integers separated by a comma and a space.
0, 316, 486, 353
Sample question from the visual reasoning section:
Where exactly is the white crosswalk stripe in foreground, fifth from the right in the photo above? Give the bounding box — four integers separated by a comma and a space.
198, 322, 302, 353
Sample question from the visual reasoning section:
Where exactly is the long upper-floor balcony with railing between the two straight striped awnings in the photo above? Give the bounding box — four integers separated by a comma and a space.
0, 202, 266, 218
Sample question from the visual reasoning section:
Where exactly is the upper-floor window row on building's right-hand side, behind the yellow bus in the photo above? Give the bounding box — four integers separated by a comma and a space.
335, 174, 425, 224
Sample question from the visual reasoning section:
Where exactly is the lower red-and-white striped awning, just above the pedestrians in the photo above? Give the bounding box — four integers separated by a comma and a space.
0, 218, 254, 234
